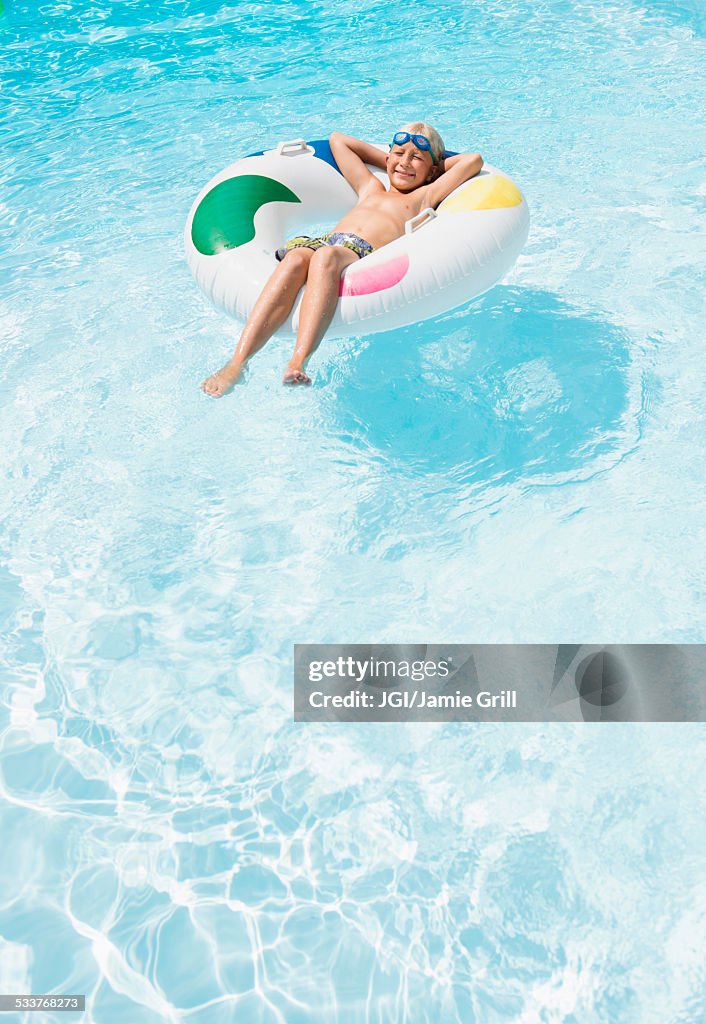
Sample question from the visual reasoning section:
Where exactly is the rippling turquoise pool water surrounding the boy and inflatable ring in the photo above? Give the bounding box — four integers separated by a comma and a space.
0, 0, 706, 1024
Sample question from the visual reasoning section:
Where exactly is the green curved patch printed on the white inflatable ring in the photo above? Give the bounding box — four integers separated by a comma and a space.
192, 174, 301, 256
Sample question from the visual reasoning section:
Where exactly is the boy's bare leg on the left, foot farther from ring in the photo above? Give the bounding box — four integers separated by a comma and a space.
201, 248, 314, 398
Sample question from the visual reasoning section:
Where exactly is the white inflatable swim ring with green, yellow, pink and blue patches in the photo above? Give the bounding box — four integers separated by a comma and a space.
184, 139, 530, 337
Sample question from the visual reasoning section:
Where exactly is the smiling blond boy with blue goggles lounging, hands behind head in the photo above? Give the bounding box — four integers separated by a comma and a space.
201, 121, 483, 398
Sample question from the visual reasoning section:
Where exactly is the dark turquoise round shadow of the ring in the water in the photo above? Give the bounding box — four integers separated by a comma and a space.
327, 288, 630, 482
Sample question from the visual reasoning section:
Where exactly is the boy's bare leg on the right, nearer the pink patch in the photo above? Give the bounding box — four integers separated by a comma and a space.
284, 246, 359, 384
